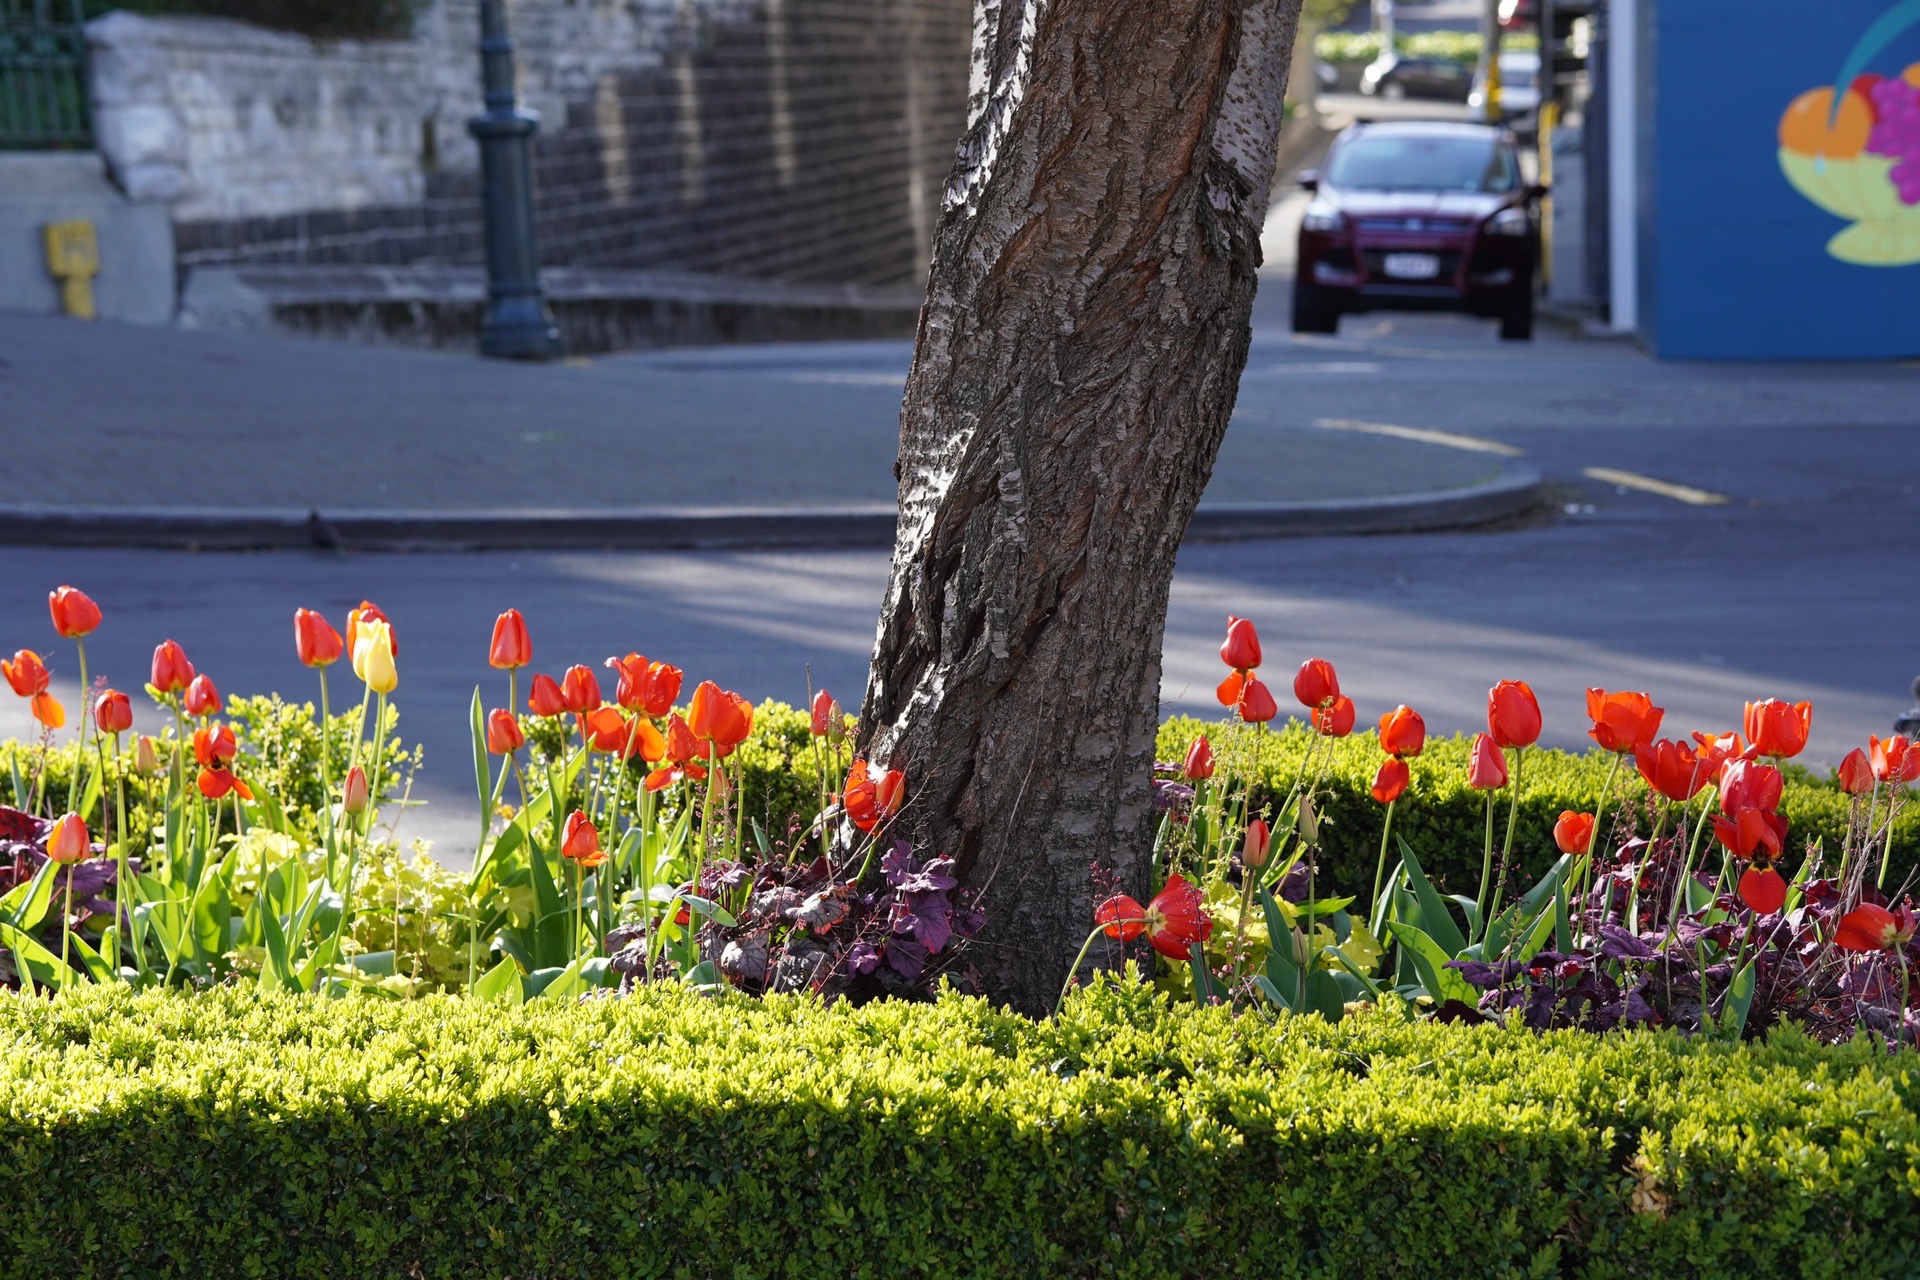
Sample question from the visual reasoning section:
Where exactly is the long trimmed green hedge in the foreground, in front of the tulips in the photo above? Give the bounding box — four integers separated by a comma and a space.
0, 984, 1920, 1280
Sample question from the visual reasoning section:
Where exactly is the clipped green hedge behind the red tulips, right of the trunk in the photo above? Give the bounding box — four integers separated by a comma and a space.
1158, 716, 1920, 894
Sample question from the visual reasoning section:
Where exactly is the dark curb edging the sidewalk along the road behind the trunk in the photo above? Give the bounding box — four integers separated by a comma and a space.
0, 466, 1544, 551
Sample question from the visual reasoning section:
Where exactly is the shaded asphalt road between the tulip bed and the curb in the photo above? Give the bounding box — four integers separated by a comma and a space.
0, 276, 1920, 864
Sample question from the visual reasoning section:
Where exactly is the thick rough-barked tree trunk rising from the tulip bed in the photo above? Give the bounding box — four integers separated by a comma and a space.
860, 0, 1300, 1013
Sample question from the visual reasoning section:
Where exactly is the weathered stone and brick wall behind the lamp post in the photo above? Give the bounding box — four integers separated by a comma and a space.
92, 0, 972, 284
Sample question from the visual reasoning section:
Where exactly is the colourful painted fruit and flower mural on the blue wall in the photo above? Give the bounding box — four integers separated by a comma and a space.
1780, 0, 1920, 267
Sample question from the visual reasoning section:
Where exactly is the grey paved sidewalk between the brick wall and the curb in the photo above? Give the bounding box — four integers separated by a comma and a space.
0, 313, 1526, 545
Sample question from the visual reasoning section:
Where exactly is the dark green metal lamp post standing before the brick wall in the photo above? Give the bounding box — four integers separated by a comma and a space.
467, 0, 561, 361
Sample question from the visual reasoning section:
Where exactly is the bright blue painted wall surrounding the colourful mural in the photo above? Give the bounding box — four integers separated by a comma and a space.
1651, 0, 1920, 359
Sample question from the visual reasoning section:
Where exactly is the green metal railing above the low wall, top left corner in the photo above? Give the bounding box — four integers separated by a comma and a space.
0, 0, 94, 152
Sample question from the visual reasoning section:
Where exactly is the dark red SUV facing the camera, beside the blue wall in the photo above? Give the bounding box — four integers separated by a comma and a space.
1294, 121, 1546, 342
